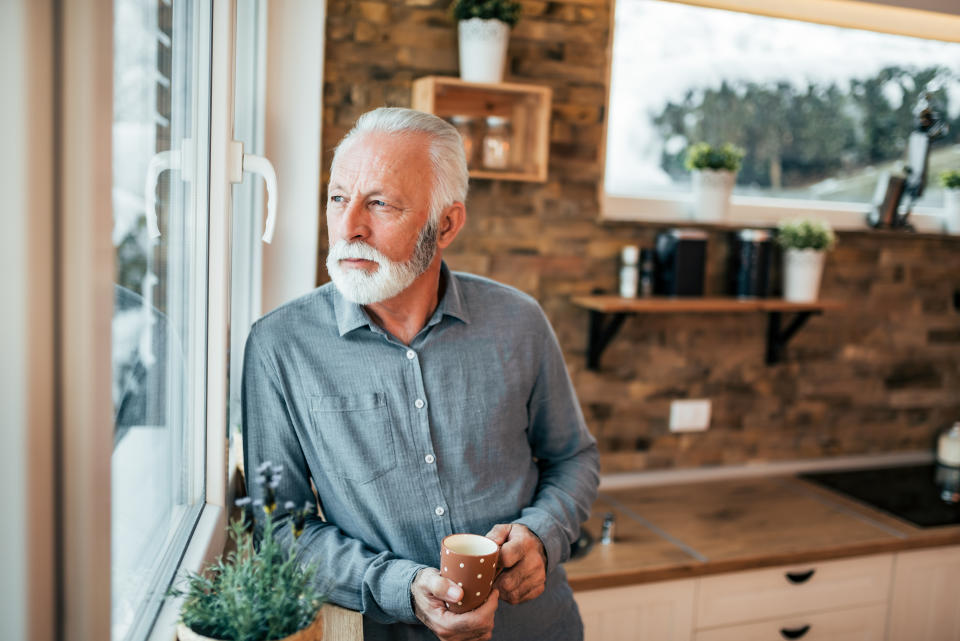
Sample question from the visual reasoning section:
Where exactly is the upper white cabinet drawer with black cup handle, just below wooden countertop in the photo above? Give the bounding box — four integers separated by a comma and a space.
697, 554, 893, 628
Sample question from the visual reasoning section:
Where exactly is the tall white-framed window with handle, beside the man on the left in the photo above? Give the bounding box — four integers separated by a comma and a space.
110, 0, 265, 641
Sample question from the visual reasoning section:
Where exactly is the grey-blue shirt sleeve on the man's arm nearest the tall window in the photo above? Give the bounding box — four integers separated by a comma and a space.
241, 325, 425, 623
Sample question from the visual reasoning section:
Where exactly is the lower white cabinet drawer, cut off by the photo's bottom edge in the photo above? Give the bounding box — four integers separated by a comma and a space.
694, 605, 886, 641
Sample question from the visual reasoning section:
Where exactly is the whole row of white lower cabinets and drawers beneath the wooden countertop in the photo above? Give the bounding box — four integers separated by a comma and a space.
574, 546, 960, 641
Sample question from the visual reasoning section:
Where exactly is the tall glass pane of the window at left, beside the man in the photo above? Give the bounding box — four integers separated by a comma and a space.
111, 0, 210, 641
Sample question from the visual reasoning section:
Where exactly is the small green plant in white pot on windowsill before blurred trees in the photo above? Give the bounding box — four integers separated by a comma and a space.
685, 142, 743, 221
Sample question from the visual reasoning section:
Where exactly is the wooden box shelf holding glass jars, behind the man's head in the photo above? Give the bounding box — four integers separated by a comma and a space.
411, 76, 553, 182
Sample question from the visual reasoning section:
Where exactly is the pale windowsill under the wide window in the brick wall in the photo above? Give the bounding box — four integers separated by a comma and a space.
600, 194, 956, 238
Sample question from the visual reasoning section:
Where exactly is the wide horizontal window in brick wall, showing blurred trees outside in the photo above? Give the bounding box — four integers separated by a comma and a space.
603, 0, 960, 227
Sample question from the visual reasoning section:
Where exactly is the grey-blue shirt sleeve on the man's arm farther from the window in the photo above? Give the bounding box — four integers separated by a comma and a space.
515, 312, 600, 573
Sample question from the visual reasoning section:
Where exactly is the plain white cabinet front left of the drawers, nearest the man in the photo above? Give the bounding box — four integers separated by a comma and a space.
574, 579, 696, 641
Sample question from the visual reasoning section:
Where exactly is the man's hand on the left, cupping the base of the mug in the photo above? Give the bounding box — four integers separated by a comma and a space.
410, 568, 499, 641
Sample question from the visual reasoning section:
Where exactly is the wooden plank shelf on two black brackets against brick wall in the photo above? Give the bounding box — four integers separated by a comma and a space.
571, 295, 844, 370
